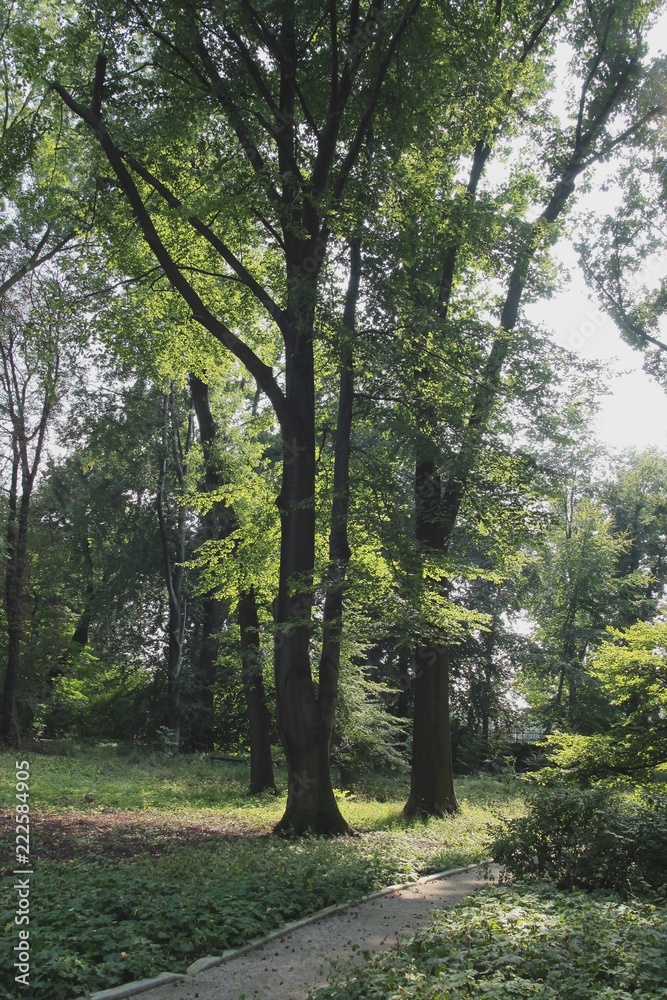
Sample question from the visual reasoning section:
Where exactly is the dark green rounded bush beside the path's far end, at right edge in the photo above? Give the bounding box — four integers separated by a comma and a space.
490, 786, 667, 894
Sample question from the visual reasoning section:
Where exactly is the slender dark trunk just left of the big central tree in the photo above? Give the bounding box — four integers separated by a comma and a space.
237, 587, 276, 795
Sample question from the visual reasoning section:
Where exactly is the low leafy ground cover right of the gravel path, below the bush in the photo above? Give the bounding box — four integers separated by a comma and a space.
312, 885, 667, 1000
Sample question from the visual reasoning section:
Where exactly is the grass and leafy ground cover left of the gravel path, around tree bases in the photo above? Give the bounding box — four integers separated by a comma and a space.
0, 752, 525, 1000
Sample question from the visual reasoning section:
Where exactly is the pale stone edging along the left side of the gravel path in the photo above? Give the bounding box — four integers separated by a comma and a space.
87, 858, 493, 1000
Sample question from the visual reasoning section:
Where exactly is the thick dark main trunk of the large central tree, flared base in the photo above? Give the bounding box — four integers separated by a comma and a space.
274, 254, 349, 834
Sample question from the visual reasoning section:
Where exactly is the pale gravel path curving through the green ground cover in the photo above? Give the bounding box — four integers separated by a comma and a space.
140, 866, 498, 1000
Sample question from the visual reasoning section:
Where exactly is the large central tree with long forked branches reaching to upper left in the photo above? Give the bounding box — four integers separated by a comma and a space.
49, 0, 430, 833
